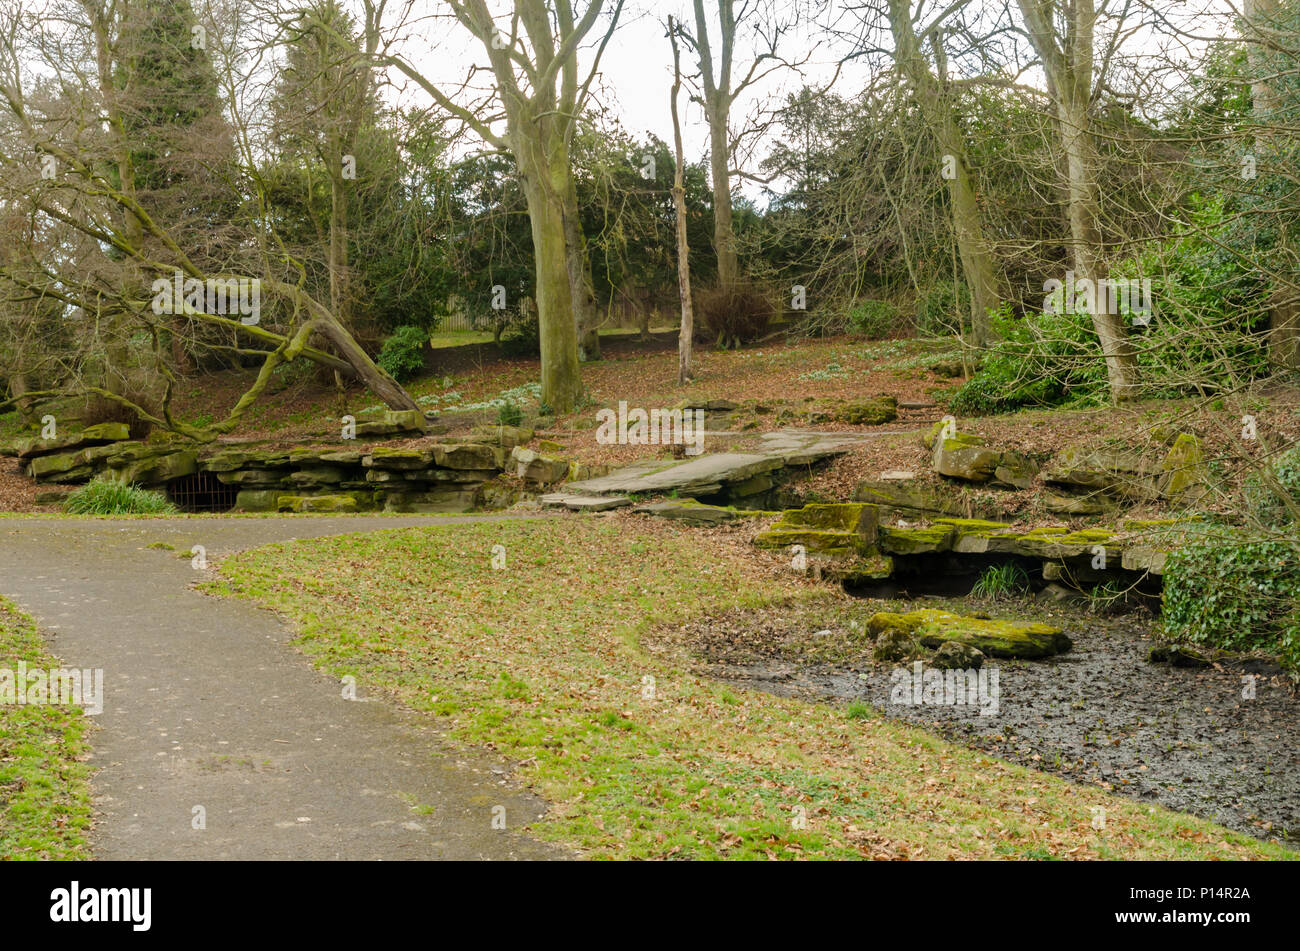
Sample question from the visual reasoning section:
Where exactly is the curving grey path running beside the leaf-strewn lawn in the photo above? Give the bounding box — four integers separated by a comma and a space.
0, 517, 564, 859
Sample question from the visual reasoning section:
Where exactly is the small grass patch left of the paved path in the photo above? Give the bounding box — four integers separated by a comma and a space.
0, 598, 92, 860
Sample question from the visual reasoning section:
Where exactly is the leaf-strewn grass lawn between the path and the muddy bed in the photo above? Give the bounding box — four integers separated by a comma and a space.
208, 520, 1291, 859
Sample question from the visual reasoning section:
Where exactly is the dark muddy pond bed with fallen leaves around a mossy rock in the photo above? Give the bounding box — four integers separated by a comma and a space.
677, 599, 1300, 847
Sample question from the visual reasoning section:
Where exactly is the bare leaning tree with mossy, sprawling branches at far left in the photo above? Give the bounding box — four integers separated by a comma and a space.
0, 0, 419, 439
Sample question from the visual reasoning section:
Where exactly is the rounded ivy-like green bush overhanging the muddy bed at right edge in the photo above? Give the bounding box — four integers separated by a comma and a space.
1164, 533, 1300, 670
